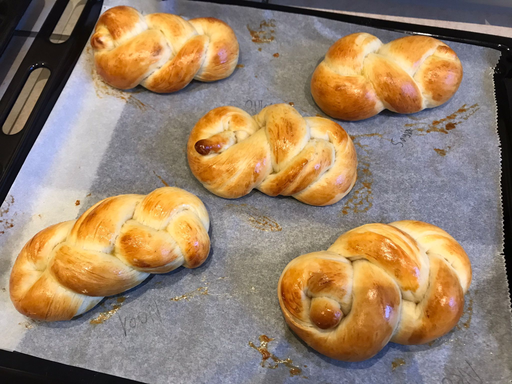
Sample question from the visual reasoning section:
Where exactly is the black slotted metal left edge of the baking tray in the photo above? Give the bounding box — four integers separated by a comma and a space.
0, 0, 103, 208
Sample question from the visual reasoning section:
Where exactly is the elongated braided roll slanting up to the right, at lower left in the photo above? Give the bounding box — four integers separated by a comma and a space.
9, 187, 210, 321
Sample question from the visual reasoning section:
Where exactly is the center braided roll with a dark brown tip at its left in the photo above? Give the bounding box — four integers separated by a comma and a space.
187, 104, 357, 205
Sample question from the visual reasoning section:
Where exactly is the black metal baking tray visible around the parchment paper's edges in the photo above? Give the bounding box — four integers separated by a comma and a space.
0, 0, 512, 382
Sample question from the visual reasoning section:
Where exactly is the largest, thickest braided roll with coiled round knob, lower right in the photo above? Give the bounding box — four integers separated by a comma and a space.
278, 221, 471, 361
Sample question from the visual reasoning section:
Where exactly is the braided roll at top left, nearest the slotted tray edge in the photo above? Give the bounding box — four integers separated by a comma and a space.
91, 6, 238, 93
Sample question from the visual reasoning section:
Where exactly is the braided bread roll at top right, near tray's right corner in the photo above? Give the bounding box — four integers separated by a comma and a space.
311, 33, 462, 120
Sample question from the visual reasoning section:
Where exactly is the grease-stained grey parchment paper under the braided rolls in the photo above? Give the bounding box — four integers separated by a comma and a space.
0, 0, 512, 384
